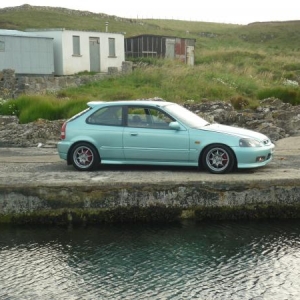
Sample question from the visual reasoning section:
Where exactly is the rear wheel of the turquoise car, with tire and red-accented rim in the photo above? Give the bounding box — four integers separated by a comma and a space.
71, 143, 100, 171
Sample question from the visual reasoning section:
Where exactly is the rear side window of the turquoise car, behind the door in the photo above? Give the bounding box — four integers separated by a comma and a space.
86, 106, 122, 126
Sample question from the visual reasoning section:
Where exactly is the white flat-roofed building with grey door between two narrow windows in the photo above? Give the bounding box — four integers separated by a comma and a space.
27, 28, 125, 75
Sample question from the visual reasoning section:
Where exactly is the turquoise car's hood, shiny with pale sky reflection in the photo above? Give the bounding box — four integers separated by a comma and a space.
202, 124, 268, 141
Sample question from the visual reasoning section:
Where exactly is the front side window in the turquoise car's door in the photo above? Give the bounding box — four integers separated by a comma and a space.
128, 106, 174, 129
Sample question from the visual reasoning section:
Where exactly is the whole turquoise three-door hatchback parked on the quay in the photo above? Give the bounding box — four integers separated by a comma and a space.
57, 100, 274, 174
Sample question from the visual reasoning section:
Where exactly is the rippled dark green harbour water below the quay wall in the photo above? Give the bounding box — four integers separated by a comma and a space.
0, 220, 300, 300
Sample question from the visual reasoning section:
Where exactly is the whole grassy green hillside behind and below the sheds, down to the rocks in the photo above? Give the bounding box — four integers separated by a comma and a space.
0, 5, 300, 118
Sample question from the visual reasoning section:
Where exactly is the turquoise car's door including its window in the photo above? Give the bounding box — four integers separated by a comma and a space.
123, 106, 189, 163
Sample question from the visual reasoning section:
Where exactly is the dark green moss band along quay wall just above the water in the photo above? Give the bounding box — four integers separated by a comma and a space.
0, 204, 300, 226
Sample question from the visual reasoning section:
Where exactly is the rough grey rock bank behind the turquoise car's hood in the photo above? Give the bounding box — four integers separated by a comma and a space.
184, 98, 300, 141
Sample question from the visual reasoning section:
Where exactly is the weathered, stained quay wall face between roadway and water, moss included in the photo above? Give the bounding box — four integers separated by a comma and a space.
0, 179, 300, 224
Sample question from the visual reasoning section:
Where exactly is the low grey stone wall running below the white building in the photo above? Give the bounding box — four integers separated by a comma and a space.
0, 62, 132, 99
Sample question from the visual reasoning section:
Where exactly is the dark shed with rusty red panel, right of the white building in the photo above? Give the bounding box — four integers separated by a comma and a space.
125, 34, 196, 65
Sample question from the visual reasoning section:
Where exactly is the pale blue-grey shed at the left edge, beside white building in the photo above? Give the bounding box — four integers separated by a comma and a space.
0, 29, 54, 75
